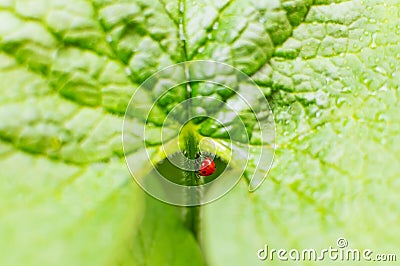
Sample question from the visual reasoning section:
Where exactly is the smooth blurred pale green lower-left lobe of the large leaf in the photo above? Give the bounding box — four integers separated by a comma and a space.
0, 140, 144, 265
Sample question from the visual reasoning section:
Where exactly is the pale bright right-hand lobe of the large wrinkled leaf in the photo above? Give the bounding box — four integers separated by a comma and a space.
199, 1, 400, 265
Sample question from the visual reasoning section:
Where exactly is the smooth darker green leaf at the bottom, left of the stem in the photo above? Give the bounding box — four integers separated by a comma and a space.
121, 176, 204, 266
